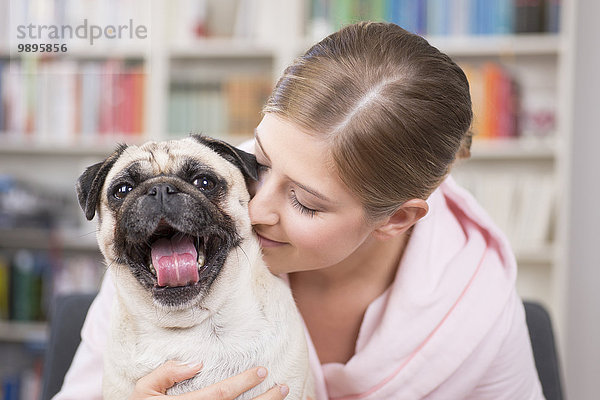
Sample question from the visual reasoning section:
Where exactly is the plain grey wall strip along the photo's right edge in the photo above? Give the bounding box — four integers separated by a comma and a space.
565, 0, 600, 400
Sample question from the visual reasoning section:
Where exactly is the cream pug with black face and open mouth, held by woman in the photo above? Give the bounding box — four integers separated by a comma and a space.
77, 135, 312, 400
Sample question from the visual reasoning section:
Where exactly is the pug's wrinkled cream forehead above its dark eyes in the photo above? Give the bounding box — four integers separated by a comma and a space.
107, 138, 241, 185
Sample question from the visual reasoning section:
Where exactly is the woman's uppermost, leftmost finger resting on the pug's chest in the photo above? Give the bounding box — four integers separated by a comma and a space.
131, 361, 202, 400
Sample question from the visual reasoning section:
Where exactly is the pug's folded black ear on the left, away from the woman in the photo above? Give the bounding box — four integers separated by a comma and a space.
77, 145, 127, 221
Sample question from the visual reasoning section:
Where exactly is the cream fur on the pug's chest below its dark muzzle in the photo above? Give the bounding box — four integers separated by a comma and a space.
105, 252, 309, 400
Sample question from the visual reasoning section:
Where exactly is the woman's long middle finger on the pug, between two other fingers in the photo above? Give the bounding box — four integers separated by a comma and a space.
176, 367, 267, 400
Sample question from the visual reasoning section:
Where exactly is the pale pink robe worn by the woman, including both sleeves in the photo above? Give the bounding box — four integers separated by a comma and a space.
55, 177, 544, 400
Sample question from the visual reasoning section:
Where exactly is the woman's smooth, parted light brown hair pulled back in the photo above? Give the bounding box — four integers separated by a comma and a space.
263, 22, 473, 219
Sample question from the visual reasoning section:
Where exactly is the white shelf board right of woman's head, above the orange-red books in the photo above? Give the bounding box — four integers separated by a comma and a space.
427, 34, 561, 57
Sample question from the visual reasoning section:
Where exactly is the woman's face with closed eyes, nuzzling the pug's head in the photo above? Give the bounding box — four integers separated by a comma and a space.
249, 114, 380, 274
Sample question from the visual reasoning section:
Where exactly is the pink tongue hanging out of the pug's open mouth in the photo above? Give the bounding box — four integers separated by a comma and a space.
151, 235, 199, 287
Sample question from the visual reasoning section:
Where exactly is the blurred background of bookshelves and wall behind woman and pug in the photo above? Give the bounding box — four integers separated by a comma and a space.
0, 0, 600, 399
